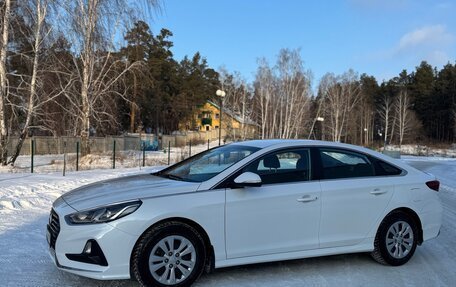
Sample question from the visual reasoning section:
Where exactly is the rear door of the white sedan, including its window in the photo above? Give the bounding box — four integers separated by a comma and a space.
319, 148, 394, 248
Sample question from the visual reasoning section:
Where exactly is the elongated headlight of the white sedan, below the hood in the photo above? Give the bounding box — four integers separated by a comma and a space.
65, 200, 142, 224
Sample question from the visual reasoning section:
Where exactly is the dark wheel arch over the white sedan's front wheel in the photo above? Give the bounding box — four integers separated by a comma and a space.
130, 217, 215, 278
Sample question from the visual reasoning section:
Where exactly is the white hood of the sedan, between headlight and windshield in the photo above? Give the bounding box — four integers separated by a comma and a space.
61, 174, 200, 211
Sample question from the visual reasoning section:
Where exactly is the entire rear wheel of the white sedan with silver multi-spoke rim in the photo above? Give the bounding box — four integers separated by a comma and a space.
371, 212, 418, 266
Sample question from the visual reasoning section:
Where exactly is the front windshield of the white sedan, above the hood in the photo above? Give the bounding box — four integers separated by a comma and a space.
156, 145, 259, 182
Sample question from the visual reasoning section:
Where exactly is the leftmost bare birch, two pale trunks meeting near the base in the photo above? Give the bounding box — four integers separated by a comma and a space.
0, 0, 53, 165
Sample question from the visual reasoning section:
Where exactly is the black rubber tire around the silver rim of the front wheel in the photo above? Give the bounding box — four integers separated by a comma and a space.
131, 221, 206, 287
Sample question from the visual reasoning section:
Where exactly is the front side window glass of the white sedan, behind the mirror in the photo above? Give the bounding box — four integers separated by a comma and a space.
243, 149, 311, 184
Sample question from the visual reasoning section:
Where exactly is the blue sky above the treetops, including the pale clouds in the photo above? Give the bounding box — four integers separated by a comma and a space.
150, 0, 456, 86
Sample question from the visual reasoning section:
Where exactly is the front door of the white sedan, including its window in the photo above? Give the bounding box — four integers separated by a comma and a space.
225, 148, 321, 259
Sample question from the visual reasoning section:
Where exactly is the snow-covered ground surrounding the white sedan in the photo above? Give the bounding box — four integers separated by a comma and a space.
0, 156, 456, 287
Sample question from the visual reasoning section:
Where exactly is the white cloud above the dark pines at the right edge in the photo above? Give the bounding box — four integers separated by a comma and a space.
396, 25, 454, 53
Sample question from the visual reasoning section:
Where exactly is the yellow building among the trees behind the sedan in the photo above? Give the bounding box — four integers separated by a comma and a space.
191, 101, 258, 139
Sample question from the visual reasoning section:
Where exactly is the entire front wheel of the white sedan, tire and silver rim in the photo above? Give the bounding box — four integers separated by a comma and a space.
132, 222, 205, 286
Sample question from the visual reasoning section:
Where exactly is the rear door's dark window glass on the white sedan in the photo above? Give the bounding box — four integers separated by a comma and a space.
320, 149, 375, 179
